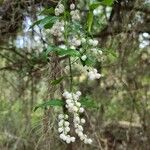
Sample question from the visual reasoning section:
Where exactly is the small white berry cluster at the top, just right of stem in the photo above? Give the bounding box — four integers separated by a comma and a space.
70, 3, 81, 21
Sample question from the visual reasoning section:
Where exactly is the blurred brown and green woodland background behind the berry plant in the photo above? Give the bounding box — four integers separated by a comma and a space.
0, 0, 150, 150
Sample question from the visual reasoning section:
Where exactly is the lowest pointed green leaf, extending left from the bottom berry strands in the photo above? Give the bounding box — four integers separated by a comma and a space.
34, 99, 65, 111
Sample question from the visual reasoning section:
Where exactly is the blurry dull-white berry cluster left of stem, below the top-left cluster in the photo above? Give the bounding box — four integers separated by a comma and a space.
50, 21, 64, 37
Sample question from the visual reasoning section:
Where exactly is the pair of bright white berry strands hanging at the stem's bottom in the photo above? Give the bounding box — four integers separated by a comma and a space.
58, 91, 92, 144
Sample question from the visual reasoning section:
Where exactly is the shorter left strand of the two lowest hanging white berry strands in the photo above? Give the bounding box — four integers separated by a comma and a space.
58, 114, 75, 144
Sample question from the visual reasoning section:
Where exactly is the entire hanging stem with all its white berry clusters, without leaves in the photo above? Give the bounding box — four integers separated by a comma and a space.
50, 1, 102, 144
